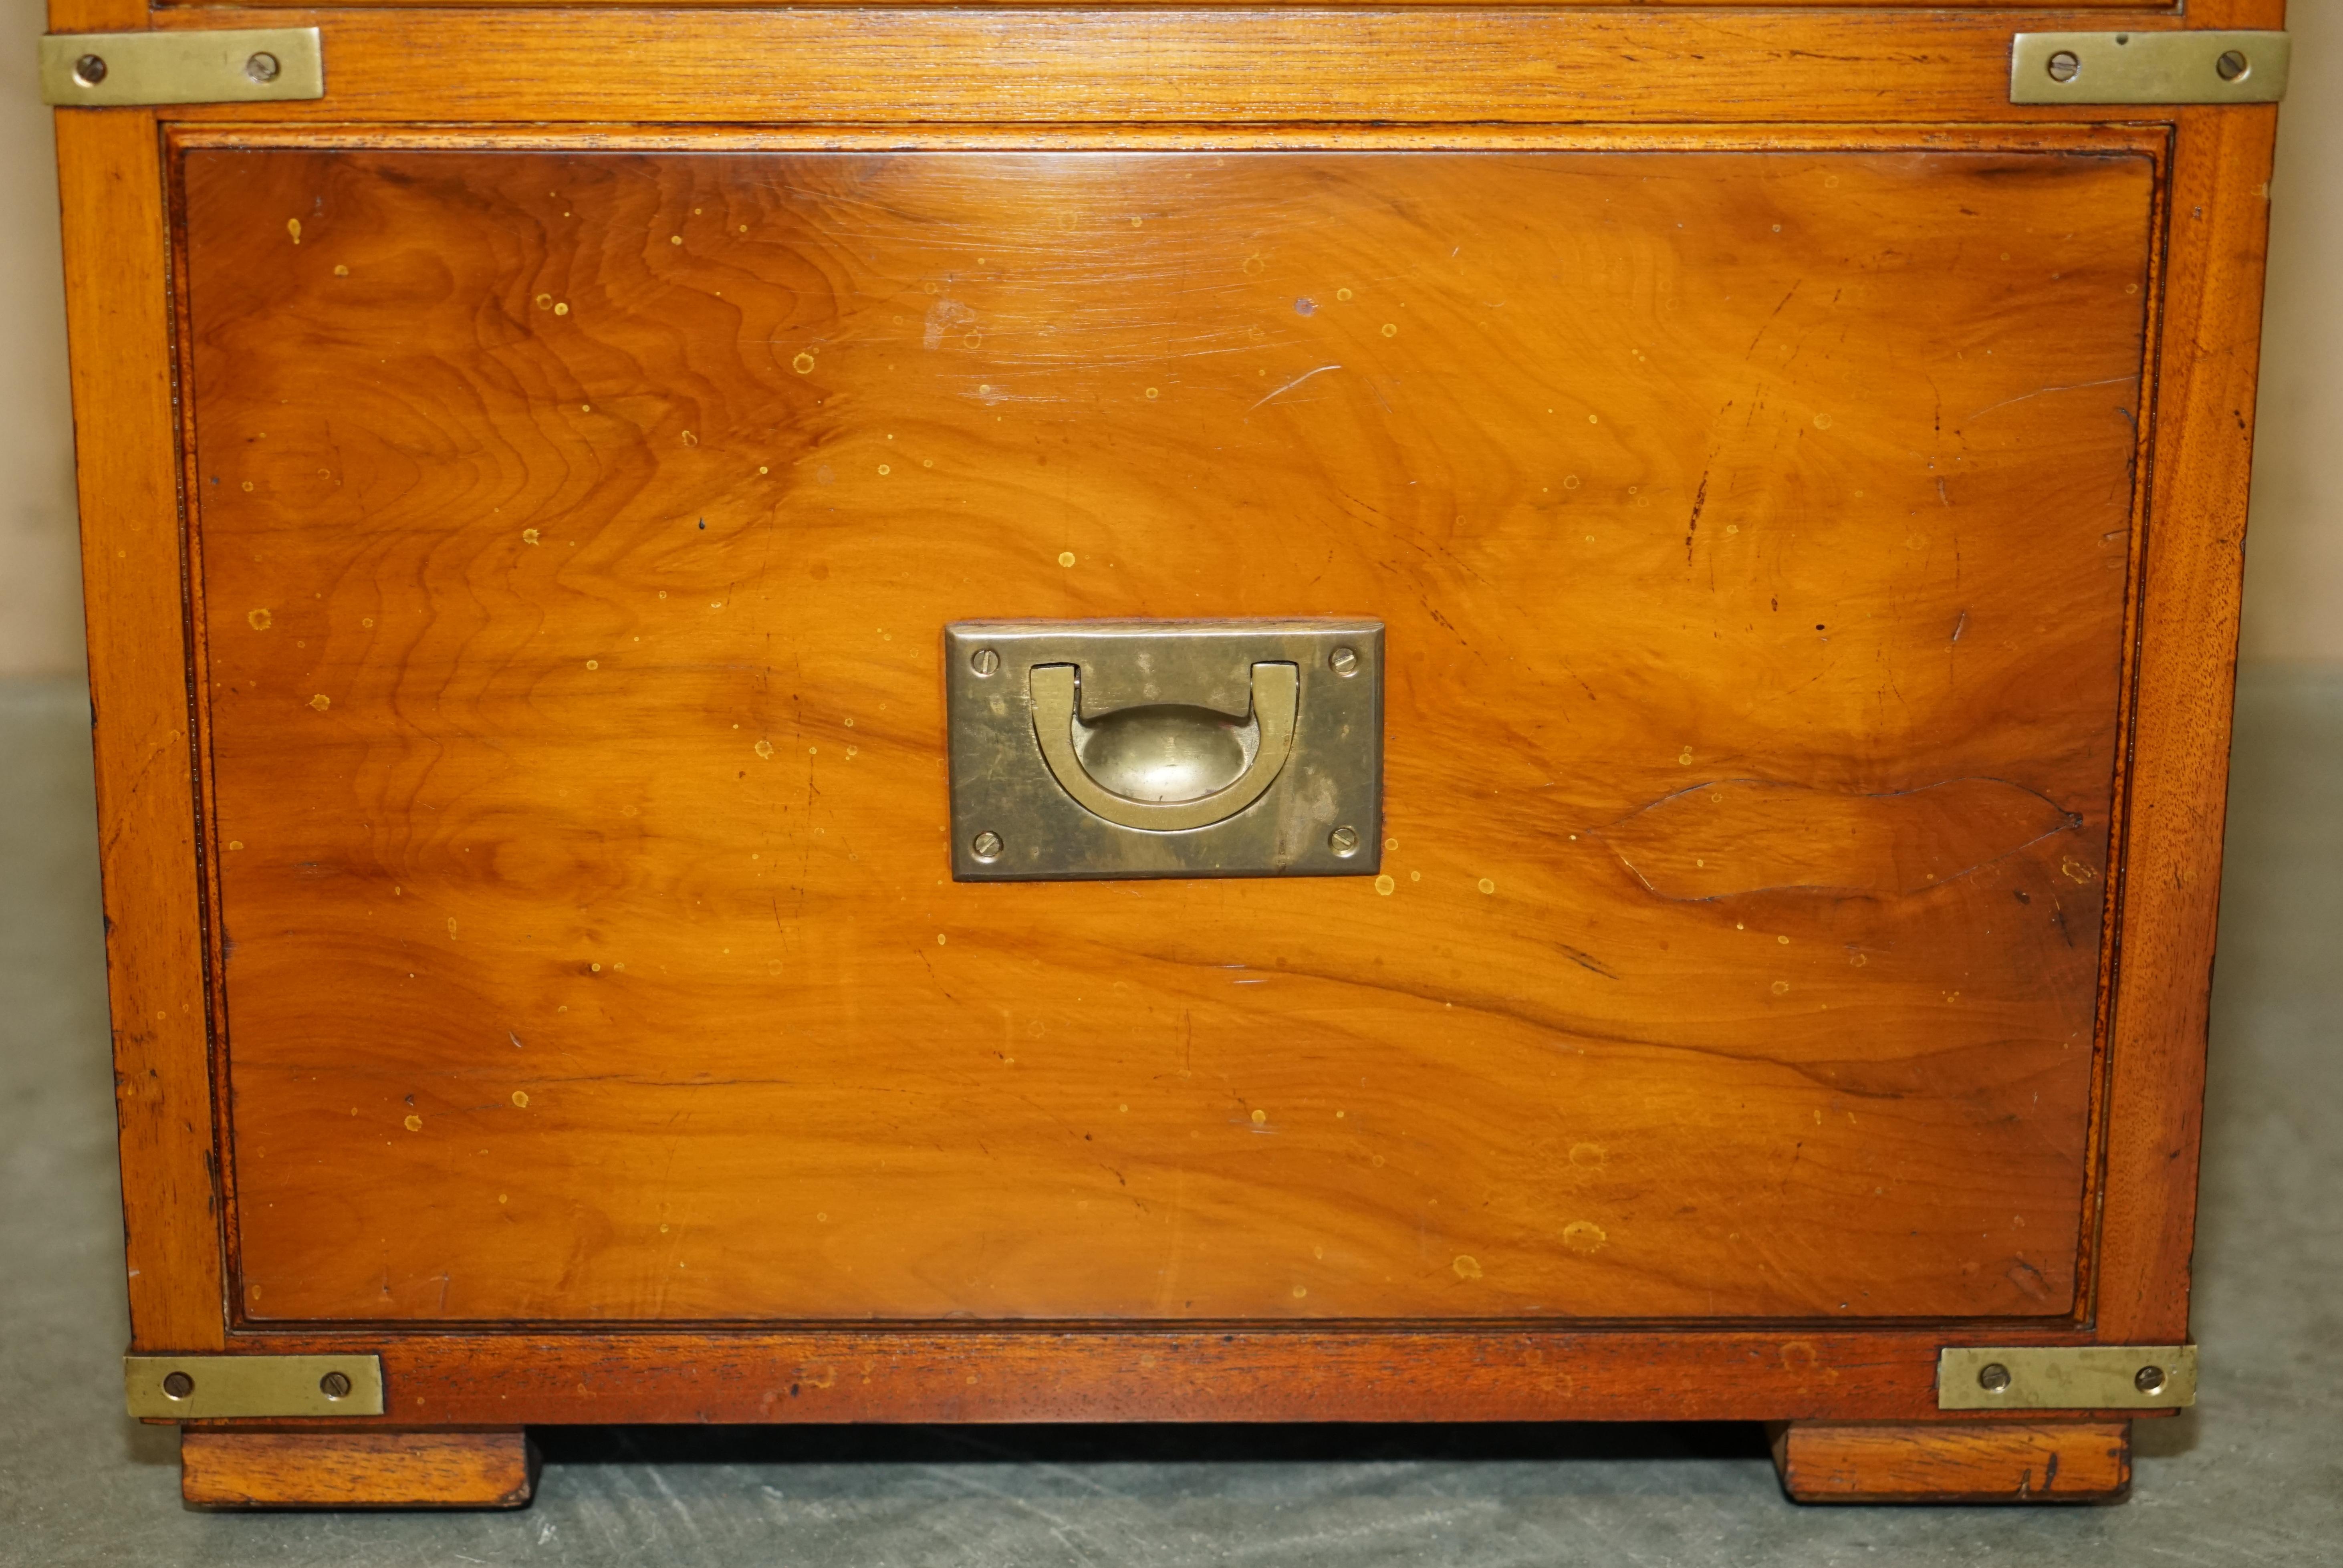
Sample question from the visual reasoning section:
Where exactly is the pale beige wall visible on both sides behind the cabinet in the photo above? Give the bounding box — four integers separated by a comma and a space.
0, 14, 2343, 675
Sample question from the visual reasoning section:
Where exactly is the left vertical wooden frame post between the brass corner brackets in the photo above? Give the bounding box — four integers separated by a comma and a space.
56, 113, 225, 1350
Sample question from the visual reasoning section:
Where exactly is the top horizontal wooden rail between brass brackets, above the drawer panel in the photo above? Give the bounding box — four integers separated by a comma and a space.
137, 0, 2275, 127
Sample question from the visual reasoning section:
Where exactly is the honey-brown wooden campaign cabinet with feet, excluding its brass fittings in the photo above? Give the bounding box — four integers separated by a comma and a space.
52, 0, 2282, 1502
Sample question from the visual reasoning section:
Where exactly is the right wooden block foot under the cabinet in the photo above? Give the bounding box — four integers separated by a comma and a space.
1771, 1420, 2132, 1502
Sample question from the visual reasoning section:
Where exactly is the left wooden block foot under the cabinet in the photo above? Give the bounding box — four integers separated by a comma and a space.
178, 1427, 536, 1507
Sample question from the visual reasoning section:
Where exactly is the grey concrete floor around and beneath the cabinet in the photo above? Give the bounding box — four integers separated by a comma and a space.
0, 670, 2343, 1568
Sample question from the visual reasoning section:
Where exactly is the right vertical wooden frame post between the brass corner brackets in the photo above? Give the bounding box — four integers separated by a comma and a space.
2095, 105, 2277, 1345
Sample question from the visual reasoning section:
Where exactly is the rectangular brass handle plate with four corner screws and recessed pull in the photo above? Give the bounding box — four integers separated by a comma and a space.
944, 621, 1382, 881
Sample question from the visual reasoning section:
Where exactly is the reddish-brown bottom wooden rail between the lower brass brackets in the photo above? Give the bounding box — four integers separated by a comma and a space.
192, 1320, 2165, 1425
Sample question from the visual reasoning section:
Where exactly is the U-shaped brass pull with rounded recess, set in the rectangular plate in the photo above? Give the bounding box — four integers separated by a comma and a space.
1028, 663, 1301, 832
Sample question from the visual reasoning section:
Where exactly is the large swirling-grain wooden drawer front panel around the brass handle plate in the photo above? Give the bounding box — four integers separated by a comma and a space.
192, 145, 2155, 1322
